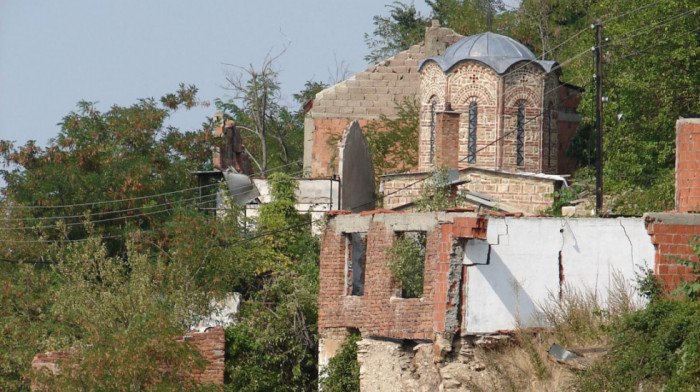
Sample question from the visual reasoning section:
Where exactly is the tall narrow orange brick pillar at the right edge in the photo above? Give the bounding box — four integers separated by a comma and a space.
676, 118, 700, 212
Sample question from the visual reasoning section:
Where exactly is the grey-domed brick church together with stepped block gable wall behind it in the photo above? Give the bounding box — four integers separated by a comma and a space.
304, 22, 582, 214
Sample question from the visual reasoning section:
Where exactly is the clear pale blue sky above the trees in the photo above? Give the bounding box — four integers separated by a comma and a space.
0, 0, 440, 145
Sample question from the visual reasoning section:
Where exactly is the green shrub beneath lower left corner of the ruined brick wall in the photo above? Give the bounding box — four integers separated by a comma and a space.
321, 331, 362, 392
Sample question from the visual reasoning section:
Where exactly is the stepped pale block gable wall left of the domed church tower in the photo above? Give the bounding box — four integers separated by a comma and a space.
304, 25, 463, 177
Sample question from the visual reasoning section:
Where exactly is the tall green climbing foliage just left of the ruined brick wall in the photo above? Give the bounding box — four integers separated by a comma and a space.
226, 173, 319, 391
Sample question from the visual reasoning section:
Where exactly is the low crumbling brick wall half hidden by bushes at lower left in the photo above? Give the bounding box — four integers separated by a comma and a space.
32, 327, 226, 390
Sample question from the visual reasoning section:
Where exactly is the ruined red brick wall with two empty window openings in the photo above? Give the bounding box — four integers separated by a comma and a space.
318, 214, 487, 339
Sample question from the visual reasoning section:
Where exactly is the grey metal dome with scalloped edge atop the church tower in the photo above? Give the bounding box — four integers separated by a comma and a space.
418, 32, 556, 74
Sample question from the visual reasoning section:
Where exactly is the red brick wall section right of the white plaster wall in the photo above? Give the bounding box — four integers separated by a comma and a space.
646, 214, 700, 291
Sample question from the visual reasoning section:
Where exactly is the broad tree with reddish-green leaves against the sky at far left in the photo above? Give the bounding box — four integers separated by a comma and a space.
0, 85, 216, 259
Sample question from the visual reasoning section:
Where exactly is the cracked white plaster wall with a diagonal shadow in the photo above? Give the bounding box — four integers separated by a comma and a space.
463, 218, 654, 333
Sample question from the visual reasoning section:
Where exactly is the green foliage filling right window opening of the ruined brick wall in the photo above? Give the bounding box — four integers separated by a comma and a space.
389, 232, 426, 298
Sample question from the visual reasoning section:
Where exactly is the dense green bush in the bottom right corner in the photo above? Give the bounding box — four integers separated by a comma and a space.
577, 299, 700, 391
